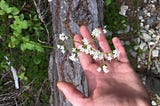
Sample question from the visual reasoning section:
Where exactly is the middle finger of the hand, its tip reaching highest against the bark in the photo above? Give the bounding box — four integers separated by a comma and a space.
80, 26, 96, 49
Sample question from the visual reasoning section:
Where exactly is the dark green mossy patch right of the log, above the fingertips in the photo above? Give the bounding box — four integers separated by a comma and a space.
104, 0, 128, 34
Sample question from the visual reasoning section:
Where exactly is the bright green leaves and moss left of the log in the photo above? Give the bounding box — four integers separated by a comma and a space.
0, 0, 48, 105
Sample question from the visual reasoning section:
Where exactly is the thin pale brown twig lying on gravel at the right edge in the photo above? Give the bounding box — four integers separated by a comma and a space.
148, 36, 160, 71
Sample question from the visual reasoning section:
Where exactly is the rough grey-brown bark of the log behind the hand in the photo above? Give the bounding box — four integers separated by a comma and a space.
49, 0, 103, 106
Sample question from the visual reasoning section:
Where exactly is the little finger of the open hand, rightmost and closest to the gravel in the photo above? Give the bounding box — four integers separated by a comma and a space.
112, 37, 128, 62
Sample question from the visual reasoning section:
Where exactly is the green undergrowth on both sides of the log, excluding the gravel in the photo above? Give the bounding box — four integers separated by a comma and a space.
0, 0, 148, 106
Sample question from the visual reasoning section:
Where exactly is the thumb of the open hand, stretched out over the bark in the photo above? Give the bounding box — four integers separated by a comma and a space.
57, 82, 85, 106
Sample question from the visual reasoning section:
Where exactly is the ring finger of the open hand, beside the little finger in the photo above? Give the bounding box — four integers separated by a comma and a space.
97, 29, 111, 52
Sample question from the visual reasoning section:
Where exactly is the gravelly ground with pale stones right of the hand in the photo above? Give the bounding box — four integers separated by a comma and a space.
118, 0, 160, 106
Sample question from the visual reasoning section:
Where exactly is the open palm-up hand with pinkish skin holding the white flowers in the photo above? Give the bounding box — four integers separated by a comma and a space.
57, 26, 150, 106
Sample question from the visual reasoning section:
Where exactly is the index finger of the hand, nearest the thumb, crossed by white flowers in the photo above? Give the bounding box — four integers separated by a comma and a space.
74, 35, 93, 70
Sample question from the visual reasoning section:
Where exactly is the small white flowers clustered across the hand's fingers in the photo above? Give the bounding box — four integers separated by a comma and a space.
57, 29, 119, 73
